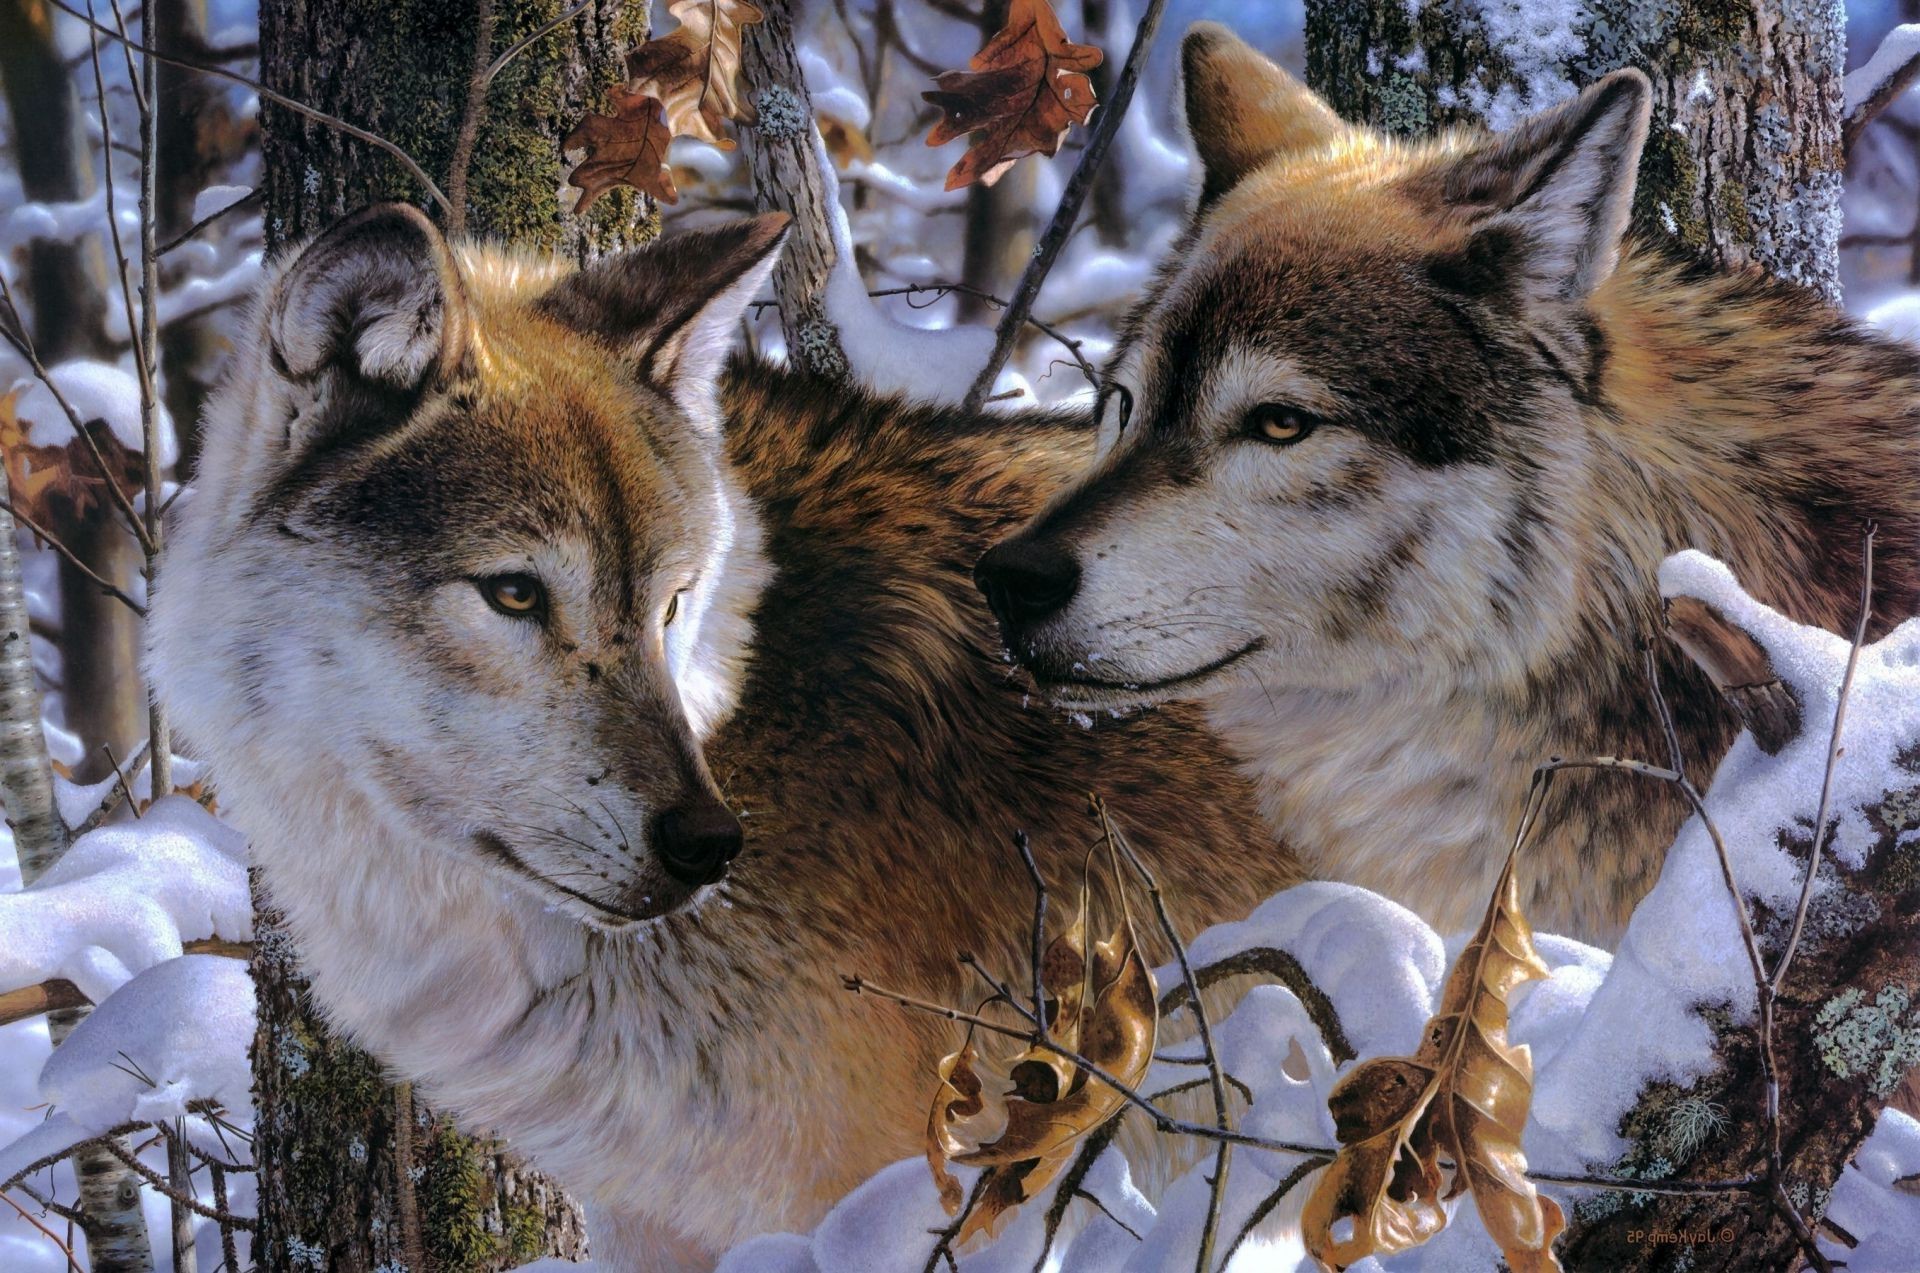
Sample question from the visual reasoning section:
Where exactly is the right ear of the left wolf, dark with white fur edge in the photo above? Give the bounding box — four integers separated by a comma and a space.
540, 213, 791, 430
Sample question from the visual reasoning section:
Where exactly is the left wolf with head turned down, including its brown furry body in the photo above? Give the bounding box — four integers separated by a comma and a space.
150, 205, 1302, 1269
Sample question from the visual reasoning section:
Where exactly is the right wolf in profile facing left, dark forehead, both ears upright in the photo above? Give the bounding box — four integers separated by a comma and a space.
977, 23, 1920, 939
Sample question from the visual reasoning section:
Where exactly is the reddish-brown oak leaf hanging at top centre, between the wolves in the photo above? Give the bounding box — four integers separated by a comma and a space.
920, 0, 1102, 190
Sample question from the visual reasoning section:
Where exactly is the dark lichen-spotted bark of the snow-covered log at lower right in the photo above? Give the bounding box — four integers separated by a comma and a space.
1557, 607, 1920, 1273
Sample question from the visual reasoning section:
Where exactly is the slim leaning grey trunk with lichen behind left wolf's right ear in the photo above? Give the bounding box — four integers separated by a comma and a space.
739, 0, 847, 376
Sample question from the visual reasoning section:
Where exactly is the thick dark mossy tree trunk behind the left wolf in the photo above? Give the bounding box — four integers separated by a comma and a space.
253, 0, 657, 1273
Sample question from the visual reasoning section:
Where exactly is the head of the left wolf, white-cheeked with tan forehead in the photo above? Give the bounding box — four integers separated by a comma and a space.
154, 205, 785, 925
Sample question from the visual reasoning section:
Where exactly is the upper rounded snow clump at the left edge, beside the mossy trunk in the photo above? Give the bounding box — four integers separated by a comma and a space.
0, 797, 253, 1002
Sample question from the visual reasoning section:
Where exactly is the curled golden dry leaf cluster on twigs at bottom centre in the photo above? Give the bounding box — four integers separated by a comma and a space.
927, 844, 1160, 1242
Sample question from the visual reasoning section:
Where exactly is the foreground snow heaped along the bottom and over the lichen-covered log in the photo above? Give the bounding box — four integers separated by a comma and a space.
698, 553, 1920, 1273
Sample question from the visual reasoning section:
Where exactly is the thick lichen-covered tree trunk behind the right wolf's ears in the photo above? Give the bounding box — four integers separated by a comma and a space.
1308, 0, 1845, 301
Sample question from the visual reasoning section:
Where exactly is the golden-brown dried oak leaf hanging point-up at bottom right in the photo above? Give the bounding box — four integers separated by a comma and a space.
1300, 840, 1565, 1273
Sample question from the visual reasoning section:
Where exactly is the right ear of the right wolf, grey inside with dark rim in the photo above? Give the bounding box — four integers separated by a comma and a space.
1442, 69, 1653, 301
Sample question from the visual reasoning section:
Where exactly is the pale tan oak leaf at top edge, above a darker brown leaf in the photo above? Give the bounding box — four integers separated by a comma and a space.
626, 0, 766, 150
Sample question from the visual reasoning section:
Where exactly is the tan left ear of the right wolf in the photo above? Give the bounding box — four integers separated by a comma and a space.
1181, 23, 1350, 211
